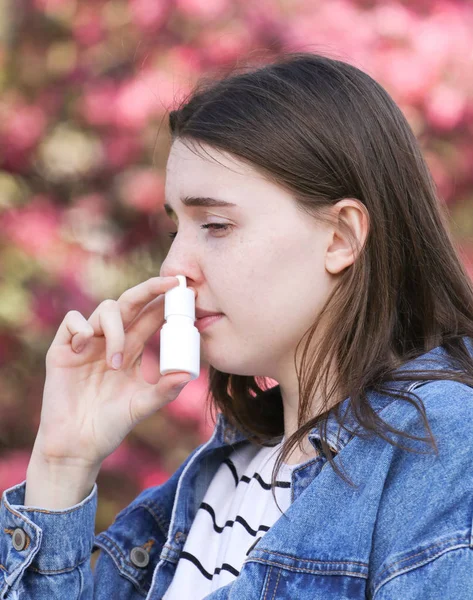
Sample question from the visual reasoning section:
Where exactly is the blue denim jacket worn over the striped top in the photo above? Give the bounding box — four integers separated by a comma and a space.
0, 338, 473, 600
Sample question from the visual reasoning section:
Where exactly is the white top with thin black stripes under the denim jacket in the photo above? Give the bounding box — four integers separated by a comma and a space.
163, 442, 297, 600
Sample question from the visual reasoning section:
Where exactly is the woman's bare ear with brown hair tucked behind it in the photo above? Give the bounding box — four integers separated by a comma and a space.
325, 198, 369, 275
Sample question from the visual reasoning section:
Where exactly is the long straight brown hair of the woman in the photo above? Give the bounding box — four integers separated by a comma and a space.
169, 52, 473, 502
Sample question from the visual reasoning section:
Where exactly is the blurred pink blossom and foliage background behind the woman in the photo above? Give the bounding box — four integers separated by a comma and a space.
0, 0, 473, 530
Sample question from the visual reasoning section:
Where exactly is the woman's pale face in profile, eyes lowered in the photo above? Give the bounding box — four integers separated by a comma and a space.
160, 140, 335, 381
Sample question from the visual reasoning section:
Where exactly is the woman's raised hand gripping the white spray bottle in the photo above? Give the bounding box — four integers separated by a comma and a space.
33, 277, 191, 470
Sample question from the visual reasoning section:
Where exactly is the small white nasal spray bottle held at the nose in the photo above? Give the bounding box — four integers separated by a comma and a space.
159, 275, 200, 379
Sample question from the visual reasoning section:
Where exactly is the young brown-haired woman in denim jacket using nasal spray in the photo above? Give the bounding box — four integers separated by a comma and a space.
0, 53, 473, 600
